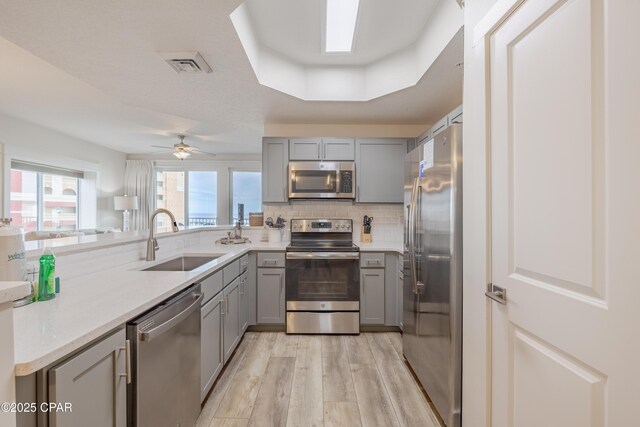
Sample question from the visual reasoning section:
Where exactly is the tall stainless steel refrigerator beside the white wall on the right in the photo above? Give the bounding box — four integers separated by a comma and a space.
403, 124, 462, 427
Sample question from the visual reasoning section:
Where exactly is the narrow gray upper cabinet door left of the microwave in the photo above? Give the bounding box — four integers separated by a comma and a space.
262, 138, 289, 203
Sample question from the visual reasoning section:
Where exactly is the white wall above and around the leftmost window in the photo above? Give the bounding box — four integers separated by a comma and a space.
0, 114, 126, 227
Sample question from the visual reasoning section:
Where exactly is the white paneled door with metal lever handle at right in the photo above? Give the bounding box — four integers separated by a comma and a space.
488, 0, 640, 427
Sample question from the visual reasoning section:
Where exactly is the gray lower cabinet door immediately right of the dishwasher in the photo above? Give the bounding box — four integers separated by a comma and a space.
200, 294, 224, 403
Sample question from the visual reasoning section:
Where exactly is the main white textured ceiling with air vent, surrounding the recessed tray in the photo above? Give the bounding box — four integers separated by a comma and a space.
0, 0, 462, 153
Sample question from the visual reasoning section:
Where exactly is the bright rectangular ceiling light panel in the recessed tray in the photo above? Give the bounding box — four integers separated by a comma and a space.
324, 0, 360, 53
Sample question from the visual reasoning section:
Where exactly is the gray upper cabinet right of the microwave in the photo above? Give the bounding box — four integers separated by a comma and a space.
356, 139, 407, 203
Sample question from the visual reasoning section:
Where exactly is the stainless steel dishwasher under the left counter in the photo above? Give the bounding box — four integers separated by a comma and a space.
127, 284, 202, 427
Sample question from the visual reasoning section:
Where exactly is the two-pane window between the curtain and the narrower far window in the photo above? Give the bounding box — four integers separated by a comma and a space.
156, 170, 218, 228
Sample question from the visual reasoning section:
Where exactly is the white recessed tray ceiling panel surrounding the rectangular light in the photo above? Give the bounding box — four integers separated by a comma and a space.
245, 0, 438, 65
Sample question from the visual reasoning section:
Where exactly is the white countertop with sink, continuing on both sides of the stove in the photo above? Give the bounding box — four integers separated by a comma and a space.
13, 242, 402, 376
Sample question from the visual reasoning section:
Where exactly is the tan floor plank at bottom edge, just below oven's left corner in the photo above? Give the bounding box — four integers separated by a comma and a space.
249, 357, 295, 427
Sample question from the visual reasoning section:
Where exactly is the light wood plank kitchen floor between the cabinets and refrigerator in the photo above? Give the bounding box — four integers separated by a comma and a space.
197, 332, 439, 427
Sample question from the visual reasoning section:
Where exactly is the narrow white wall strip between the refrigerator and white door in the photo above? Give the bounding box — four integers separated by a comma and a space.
462, 0, 497, 427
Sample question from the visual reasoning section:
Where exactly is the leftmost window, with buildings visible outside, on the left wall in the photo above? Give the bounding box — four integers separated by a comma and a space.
9, 161, 82, 231
